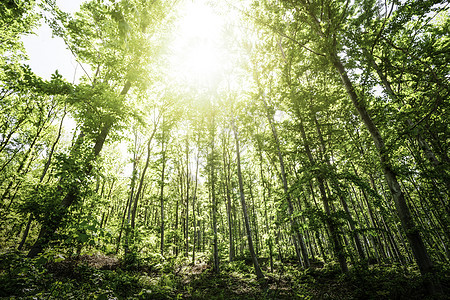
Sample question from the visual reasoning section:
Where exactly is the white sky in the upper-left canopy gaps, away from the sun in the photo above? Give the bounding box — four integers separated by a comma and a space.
22, 0, 83, 82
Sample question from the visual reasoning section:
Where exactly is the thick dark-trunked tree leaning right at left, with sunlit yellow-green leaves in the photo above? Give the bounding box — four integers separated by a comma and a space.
29, 2, 171, 257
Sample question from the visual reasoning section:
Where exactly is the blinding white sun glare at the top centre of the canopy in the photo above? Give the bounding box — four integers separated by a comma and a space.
170, 1, 224, 85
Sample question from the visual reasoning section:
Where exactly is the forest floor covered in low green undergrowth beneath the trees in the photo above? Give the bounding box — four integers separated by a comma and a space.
0, 253, 450, 300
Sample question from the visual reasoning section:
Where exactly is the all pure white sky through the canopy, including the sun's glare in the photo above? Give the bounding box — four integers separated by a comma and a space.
23, 0, 229, 84
